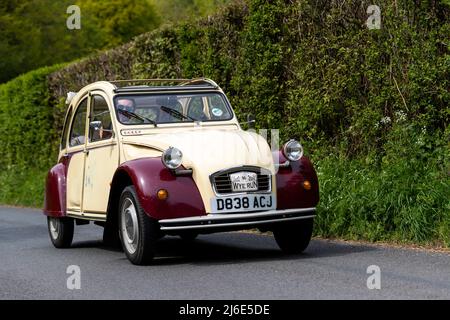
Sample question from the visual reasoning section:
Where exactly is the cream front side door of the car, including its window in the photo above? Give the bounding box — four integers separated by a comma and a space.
83, 91, 119, 218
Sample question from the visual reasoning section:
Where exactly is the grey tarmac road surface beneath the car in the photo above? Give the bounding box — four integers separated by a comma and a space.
0, 207, 450, 300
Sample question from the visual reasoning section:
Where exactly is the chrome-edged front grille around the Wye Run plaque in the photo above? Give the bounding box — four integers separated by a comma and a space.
211, 167, 272, 194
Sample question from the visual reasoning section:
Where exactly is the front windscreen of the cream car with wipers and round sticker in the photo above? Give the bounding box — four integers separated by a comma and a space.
114, 93, 233, 125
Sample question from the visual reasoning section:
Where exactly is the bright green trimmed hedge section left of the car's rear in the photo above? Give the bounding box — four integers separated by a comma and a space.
0, 66, 61, 206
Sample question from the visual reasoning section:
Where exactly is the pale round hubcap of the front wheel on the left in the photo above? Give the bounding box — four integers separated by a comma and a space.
120, 198, 139, 254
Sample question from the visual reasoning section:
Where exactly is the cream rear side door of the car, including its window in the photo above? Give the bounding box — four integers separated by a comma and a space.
66, 96, 89, 214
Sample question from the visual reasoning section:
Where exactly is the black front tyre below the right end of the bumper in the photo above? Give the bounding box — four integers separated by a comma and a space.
273, 219, 314, 254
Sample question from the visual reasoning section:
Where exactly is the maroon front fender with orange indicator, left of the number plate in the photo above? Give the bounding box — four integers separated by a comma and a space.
116, 158, 206, 220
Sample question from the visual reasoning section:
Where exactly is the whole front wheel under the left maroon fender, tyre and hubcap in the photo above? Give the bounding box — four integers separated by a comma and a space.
119, 186, 159, 265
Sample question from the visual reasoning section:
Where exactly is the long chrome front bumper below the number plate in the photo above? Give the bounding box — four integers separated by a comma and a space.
159, 208, 316, 232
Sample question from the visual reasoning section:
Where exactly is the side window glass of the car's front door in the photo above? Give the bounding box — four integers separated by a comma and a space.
89, 95, 113, 142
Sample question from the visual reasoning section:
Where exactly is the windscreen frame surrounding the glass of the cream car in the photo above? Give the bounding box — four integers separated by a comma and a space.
113, 90, 235, 127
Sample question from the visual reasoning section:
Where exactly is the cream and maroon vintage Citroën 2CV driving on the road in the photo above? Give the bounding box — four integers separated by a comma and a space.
44, 79, 319, 264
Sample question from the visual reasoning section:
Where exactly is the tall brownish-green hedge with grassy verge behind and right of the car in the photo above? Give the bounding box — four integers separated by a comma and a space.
0, 0, 450, 245
